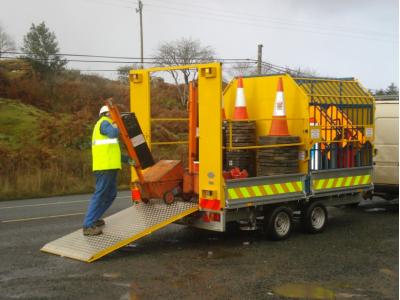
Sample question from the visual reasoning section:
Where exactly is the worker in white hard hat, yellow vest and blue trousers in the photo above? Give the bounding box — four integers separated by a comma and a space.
83, 105, 134, 235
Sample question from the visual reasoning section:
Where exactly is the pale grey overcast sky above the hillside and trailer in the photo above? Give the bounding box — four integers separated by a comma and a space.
0, 0, 399, 89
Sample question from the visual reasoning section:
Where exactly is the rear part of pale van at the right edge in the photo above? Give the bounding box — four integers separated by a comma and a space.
374, 96, 399, 202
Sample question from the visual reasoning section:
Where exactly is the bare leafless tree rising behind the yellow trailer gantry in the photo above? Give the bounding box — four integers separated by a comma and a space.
154, 38, 215, 106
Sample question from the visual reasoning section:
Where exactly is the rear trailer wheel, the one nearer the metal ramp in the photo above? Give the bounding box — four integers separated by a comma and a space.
264, 206, 293, 241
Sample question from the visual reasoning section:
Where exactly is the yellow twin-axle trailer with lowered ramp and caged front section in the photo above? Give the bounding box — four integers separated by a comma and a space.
42, 63, 374, 262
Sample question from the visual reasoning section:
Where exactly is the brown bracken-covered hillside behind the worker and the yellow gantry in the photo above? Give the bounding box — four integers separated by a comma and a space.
0, 59, 187, 200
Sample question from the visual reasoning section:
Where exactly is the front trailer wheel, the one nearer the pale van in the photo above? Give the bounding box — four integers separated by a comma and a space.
303, 202, 328, 233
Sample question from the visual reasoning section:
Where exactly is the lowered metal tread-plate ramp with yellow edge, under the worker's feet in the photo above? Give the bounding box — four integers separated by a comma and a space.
40, 200, 198, 262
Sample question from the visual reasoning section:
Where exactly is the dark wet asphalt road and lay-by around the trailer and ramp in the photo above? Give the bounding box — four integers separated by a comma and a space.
0, 192, 399, 299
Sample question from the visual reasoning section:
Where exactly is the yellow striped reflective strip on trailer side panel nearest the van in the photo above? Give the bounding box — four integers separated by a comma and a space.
313, 174, 371, 190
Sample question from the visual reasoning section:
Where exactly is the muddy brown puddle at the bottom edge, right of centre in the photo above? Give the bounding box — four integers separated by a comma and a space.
272, 283, 335, 299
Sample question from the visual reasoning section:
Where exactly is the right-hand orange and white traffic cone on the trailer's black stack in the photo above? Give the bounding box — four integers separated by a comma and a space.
269, 77, 289, 136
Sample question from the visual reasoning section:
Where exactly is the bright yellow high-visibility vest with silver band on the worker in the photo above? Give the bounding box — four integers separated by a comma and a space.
92, 116, 121, 171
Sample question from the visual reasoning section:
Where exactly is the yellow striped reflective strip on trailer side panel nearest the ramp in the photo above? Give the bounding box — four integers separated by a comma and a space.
228, 181, 303, 200
